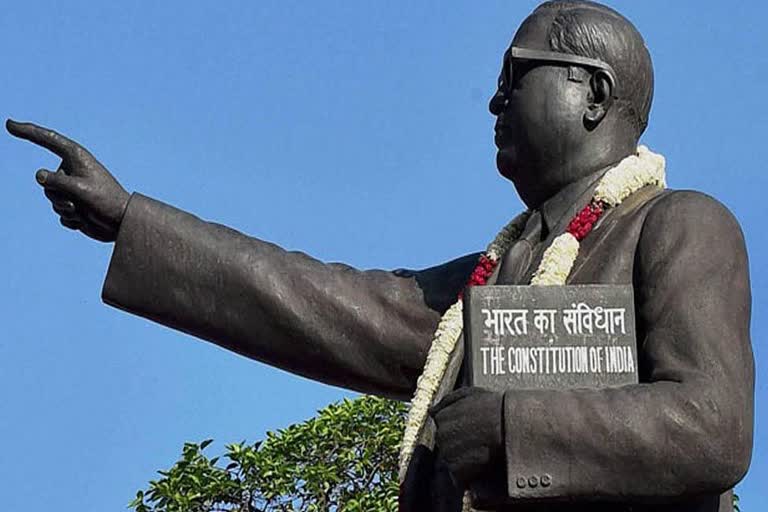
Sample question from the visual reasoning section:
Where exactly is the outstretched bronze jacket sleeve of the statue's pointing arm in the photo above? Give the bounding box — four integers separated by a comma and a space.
102, 194, 476, 398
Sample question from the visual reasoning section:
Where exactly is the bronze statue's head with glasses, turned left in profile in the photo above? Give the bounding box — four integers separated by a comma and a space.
489, 0, 653, 207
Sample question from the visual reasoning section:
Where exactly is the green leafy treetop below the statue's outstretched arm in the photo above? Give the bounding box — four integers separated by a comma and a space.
129, 396, 406, 512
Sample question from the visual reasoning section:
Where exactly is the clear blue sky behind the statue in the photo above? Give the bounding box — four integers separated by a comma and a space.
0, 0, 768, 512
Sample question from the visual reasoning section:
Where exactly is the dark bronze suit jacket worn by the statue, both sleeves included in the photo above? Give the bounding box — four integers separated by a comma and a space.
103, 182, 754, 512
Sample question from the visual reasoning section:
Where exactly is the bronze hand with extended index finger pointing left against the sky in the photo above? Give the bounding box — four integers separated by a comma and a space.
5, 119, 130, 242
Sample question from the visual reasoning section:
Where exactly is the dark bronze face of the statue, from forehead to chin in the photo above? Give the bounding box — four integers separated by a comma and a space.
489, 15, 590, 207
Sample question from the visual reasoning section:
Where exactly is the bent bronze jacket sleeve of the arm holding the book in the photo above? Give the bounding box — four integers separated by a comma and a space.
504, 192, 754, 501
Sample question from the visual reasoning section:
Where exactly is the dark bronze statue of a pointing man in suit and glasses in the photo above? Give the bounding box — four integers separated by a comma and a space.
7, 1, 754, 512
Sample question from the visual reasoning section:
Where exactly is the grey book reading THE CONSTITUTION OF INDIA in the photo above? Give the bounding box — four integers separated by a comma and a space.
464, 285, 638, 391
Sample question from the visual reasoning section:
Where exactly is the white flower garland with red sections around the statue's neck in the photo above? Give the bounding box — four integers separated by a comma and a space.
399, 146, 666, 511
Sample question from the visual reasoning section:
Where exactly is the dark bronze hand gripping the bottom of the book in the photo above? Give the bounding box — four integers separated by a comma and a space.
429, 387, 504, 489
